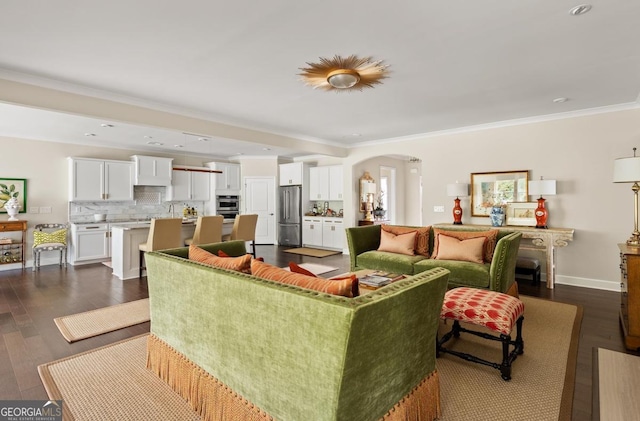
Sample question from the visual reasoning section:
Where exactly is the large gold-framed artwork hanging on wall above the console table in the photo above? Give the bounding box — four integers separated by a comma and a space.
471, 170, 529, 217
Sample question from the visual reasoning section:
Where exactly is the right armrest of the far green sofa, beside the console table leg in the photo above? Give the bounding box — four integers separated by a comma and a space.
489, 232, 522, 293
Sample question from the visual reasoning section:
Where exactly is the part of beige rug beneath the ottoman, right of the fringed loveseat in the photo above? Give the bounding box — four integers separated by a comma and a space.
436, 296, 582, 421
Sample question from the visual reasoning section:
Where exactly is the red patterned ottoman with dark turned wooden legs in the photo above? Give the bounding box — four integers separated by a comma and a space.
436, 287, 524, 380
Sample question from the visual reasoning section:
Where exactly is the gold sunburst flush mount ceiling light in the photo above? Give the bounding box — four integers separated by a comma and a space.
299, 55, 389, 92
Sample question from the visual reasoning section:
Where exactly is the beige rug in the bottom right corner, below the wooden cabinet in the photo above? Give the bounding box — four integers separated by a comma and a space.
593, 348, 640, 421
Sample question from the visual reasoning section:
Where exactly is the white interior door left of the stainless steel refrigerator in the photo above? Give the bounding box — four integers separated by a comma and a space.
243, 177, 277, 244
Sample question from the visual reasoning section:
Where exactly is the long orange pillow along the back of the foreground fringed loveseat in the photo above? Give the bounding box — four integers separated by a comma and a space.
251, 259, 353, 297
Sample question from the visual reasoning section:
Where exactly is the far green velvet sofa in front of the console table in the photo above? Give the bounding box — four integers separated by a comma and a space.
346, 225, 522, 295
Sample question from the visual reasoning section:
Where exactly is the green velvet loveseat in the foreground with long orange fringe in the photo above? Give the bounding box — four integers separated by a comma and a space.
146, 241, 448, 421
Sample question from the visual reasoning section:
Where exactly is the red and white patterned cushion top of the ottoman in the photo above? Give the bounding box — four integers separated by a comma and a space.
440, 287, 524, 335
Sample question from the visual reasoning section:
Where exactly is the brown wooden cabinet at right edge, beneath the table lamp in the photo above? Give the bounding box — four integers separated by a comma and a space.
618, 244, 640, 351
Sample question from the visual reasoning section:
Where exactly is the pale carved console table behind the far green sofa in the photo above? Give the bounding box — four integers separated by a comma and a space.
434, 224, 574, 289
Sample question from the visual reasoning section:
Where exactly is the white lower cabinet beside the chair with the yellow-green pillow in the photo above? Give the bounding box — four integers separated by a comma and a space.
70, 223, 111, 265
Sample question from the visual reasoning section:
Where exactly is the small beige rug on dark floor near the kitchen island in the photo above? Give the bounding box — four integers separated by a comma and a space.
53, 298, 150, 342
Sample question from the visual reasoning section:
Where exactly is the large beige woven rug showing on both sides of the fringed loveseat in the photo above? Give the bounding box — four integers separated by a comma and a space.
38, 297, 582, 421
